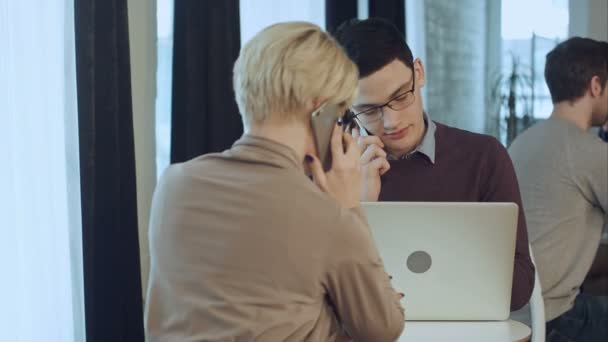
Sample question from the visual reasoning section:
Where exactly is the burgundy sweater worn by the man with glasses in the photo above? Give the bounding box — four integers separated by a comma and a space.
380, 122, 534, 311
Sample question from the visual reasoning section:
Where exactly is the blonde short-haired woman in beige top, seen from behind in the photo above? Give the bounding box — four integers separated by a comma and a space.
145, 23, 404, 342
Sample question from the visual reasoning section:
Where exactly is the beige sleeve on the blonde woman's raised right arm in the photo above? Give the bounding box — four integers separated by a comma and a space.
325, 209, 405, 341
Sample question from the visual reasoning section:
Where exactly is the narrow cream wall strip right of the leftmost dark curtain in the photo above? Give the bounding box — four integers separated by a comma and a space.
128, 0, 156, 294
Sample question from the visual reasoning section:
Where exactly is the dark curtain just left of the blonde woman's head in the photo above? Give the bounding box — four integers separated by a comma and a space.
171, 0, 243, 163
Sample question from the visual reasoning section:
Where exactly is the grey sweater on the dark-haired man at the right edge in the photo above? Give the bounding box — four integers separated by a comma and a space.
509, 119, 608, 321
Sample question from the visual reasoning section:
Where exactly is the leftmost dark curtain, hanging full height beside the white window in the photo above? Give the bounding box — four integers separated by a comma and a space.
74, 0, 144, 342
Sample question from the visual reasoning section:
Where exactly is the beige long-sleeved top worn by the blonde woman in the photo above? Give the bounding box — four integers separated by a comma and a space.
145, 136, 404, 342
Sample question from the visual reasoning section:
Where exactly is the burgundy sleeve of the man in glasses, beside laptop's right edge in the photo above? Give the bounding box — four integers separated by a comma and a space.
481, 138, 534, 311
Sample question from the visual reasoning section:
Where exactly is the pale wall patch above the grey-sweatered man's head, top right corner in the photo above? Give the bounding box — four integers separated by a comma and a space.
569, 0, 608, 41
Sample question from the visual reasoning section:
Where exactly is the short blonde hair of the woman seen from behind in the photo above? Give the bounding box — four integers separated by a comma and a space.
233, 22, 359, 127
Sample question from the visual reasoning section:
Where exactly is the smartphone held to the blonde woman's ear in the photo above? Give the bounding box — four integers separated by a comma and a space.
311, 104, 344, 171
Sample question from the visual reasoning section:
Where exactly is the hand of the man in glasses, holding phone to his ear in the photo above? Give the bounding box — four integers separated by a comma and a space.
352, 129, 391, 202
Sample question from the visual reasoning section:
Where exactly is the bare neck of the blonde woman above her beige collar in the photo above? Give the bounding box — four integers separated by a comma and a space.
245, 121, 310, 160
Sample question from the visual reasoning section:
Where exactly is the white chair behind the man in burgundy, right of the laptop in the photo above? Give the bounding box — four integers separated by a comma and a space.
511, 248, 546, 342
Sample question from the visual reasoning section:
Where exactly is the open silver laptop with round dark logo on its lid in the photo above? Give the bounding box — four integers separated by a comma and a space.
362, 202, 518, 321
